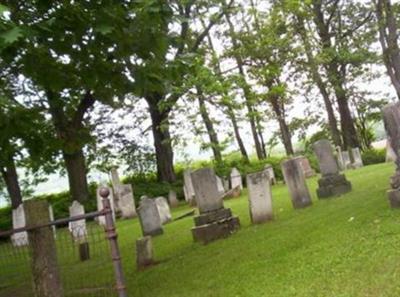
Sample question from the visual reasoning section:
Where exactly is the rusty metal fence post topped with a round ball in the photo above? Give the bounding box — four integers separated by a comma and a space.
100, 187, 128, 297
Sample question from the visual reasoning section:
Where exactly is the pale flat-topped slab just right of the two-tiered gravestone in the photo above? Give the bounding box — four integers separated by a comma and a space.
246, 171, 273, 224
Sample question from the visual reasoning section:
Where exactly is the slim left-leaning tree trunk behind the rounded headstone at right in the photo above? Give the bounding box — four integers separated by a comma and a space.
297, 16, 342, 147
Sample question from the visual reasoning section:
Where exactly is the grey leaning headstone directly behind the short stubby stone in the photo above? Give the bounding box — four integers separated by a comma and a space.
138, 198, 164, 236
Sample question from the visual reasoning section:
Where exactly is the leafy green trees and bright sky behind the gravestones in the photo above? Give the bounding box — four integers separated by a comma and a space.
0, 0, 400, 222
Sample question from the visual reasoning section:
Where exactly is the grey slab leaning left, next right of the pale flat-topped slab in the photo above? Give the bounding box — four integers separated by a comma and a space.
281, 158, 312, 208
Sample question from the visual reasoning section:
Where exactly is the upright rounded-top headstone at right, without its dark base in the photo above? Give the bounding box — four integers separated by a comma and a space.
313, 139, 339, 175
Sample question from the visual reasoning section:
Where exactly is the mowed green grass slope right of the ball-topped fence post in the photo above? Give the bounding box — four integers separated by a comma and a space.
117, 164, 400, 297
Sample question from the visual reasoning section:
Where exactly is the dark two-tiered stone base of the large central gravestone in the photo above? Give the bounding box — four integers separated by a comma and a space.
192, 208, 240, 244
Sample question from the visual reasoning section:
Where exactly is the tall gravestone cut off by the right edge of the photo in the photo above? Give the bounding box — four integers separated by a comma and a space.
383, 102, 400, 208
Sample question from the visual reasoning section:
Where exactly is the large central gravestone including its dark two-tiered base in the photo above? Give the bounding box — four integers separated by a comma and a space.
192, 168, 240, 244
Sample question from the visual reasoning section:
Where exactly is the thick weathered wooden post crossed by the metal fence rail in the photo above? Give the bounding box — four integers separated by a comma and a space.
24, 200, 63, 297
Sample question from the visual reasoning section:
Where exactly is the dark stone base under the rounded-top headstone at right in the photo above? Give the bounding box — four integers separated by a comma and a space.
317, 174, 351, 198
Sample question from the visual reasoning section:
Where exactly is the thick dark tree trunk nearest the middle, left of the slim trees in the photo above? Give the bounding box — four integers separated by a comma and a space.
145, 94, 176, 183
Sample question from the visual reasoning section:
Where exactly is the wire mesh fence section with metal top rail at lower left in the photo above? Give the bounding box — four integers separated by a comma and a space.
0, 190, 127, 297
